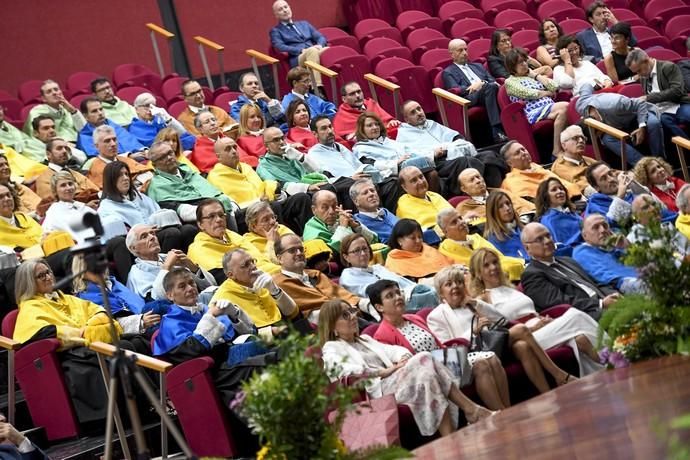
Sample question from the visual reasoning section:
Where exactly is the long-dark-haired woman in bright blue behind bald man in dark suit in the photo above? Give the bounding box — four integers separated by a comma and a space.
534, 177, 583, 250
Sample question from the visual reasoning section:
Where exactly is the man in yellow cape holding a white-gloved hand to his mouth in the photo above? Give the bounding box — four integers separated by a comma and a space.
212, 249, 299, 341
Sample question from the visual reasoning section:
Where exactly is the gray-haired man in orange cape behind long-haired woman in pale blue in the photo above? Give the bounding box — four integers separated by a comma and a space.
85, 125, 153, 190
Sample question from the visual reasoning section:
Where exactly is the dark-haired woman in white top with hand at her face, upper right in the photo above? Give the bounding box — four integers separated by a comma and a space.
553, 35, 613, 97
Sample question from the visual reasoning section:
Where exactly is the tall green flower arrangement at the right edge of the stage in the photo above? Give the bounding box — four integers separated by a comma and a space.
599, 221, 690, 367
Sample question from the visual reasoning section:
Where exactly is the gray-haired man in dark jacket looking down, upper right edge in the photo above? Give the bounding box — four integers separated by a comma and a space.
625, 49, 690, 139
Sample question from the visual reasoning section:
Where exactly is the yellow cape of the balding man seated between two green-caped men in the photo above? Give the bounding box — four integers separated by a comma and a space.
206, 163, 278, 209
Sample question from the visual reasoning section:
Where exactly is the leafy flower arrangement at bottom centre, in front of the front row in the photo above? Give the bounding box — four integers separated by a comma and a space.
232, 333, 409, 460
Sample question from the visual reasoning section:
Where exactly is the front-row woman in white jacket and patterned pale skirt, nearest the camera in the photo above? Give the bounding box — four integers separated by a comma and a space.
319, 300, 491, 436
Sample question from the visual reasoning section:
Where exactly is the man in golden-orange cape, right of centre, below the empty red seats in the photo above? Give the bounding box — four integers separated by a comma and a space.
501, 141, 581, 199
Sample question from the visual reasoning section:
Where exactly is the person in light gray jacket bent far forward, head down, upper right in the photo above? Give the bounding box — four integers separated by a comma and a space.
575, 84, 666, 166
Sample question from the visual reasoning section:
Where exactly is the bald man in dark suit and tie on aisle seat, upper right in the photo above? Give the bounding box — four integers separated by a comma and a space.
442, 38, 508, 142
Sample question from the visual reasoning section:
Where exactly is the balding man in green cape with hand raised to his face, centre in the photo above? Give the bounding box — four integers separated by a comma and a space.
303, 190, 378, 253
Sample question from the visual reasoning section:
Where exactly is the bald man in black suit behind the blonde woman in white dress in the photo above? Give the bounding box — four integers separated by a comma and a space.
521, 222, 620, 320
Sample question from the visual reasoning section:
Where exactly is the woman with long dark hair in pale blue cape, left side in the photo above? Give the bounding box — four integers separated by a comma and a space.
98, 161, 199, 253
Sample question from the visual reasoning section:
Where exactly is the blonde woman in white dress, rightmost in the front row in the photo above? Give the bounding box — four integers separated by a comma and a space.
470, 248, 603, 376
